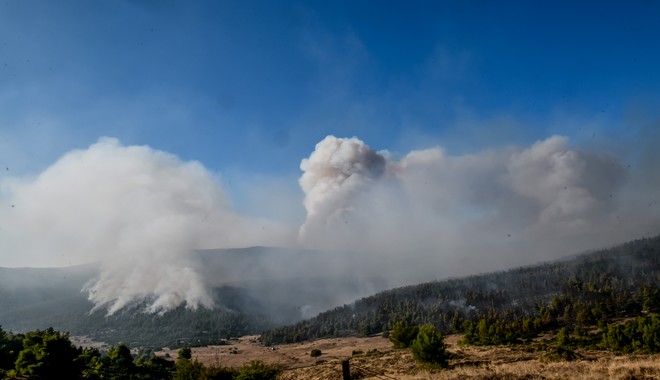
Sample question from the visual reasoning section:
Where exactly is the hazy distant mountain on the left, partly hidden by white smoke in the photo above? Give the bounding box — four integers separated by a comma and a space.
0, 247, 385, 348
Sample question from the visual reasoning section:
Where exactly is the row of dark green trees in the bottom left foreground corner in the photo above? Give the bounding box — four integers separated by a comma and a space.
0, 328, 280, 380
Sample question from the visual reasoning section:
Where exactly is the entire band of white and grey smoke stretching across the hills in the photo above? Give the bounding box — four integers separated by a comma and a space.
0, 136, 660, 313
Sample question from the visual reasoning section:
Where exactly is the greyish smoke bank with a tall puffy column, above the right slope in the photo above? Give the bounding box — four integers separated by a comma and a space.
299, 136, 660, 284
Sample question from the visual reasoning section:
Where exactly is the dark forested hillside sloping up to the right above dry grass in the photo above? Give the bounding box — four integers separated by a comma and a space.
262, 236, 660, 344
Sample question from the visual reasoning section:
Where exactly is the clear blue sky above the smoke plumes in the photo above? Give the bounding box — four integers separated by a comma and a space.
0, 0, 660, 208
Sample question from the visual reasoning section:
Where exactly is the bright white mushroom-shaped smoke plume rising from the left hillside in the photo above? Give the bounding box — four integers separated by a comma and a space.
0, 138, 286, 313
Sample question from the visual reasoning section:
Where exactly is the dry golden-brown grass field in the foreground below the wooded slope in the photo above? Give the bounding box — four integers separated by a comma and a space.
160, 335, 660, 380
